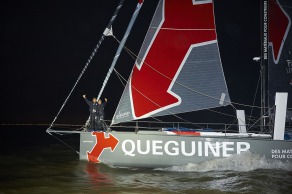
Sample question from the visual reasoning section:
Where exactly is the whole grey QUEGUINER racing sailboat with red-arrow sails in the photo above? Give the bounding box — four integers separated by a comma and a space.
47, 0, 292, 168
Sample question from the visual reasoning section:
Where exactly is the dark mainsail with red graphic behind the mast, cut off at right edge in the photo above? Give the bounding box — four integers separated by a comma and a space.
268, 0, 292, 108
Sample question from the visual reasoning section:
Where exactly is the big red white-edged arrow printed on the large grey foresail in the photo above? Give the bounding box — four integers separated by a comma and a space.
131, 0, 216, 117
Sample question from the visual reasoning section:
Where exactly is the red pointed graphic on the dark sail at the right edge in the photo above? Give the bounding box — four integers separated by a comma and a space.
269, 1, 290, 64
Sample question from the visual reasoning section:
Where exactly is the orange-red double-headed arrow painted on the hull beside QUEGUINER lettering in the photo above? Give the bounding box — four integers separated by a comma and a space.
87, 132, 119, 163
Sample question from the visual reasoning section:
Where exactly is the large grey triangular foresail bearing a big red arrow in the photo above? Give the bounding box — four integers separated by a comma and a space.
112, 0, 230, 124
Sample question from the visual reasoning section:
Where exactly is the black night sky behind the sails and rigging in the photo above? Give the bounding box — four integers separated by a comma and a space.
0, 0, 260, 124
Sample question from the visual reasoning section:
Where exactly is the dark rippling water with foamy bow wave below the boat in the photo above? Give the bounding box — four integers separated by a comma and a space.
0, 128, 292, 194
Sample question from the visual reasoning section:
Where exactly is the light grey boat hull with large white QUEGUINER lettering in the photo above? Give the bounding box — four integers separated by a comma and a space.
80, 131, 292, 168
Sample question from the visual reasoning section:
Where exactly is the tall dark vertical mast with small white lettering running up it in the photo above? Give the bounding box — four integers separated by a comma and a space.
260, 0, 269, 132
